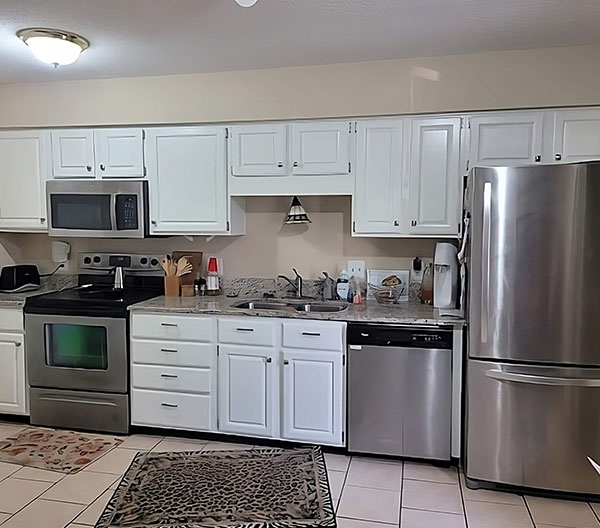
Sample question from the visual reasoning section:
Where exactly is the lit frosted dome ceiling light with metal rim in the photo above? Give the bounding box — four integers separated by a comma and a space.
17, 28, 90, 68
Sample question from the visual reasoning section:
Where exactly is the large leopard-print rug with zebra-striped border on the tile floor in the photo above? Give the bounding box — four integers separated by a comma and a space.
96, 447, 336, 528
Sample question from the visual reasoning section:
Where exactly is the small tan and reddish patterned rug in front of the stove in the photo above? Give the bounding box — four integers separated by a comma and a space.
0, 427, 123, 473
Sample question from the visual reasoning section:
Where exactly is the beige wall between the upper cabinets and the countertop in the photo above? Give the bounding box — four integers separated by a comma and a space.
0, 197, 435, 278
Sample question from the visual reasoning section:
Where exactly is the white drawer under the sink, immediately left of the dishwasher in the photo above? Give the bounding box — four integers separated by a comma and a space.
283, 321, 345, 352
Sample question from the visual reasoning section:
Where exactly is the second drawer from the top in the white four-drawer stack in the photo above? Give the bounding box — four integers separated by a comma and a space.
131, 339, 217, 367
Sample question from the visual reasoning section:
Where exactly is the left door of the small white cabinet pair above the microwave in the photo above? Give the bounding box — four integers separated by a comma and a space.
51, 129, 96, 178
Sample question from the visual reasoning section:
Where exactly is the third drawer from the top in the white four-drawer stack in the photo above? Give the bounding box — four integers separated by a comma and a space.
131, 365, 212, 393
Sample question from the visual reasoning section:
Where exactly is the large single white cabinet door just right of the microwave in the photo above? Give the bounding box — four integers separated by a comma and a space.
146, 127, 227, 235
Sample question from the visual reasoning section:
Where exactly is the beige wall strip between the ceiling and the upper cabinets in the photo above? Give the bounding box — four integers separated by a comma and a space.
0, 45, 600, 127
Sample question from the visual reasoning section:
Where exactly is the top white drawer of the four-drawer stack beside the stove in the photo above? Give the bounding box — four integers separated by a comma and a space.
132, 314, 216, 341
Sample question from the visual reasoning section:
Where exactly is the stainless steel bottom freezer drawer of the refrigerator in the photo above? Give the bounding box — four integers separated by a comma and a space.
466, 360, 600, 494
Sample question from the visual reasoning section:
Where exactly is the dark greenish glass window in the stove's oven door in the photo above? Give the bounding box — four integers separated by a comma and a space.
45, 324, 108, 370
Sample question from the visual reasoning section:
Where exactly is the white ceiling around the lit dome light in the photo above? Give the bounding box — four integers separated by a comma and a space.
0, 0, 600, 83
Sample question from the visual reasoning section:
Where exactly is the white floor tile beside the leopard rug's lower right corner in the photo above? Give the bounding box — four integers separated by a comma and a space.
338, 484, 400, 524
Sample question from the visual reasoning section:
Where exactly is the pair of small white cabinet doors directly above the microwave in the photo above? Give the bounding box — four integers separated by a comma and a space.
51, 128, 144, 178
